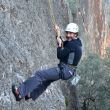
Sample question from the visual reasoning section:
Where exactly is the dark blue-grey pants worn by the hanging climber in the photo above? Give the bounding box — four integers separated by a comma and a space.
19, 64, 75, 100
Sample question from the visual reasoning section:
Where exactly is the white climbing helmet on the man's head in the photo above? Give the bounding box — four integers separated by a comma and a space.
65, 23, 79, 33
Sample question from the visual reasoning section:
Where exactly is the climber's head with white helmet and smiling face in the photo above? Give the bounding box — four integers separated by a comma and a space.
65, 23, 79, 41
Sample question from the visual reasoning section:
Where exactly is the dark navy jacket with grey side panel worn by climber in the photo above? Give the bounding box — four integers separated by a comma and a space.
57, 38, 82, 66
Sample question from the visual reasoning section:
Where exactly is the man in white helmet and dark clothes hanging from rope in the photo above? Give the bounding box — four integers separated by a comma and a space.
12, 23, 82, 101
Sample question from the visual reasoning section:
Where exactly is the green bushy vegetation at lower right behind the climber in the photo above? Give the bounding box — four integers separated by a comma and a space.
78, 48, 110, 110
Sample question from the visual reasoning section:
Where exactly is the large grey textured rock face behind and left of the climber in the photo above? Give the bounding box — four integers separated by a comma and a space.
0, 0, 69, 110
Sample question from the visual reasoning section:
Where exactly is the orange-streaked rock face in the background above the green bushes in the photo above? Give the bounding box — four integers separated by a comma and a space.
77, 0, 110, 57
